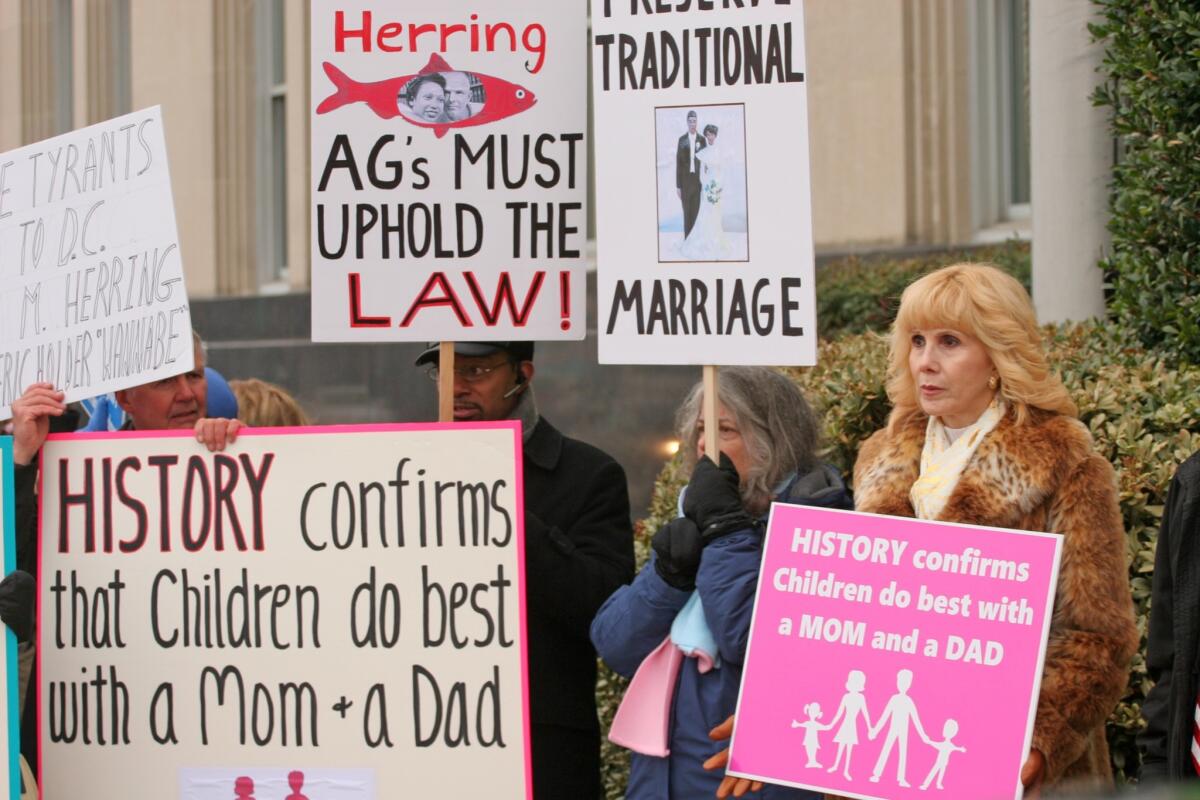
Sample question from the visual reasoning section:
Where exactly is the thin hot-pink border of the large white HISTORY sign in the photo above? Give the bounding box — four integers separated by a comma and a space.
36, 420, 533, 800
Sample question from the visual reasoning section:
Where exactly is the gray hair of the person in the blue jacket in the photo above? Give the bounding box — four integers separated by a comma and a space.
676, 367, 820, 512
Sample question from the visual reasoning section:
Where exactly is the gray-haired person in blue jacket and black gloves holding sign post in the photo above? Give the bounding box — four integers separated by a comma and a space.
592, 367, 853, 800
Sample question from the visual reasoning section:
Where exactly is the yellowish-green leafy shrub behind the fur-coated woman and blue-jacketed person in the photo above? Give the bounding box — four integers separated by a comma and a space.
602, 323, 1200, 798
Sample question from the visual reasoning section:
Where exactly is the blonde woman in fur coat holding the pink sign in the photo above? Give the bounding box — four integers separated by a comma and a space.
854, 264, 1138, 798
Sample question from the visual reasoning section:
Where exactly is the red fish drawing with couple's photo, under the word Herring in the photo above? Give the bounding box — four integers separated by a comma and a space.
317, 53, 538, 139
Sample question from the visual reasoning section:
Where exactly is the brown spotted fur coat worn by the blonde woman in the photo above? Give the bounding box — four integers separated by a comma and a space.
854, 409, 1138, 788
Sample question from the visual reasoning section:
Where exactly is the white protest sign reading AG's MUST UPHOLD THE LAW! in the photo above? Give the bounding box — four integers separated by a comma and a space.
311, 0, 587, 342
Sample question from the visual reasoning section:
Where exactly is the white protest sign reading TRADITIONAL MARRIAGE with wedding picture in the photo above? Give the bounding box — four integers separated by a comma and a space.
592, 0, 816, 365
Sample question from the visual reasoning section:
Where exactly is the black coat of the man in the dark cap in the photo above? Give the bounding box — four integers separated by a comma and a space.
524, 417, 634, 800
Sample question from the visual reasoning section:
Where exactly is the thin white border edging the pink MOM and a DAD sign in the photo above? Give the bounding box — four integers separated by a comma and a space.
726, 503, 1062, 800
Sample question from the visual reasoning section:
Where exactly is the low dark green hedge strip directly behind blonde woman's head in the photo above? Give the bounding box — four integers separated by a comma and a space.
817, 241, 1030, 339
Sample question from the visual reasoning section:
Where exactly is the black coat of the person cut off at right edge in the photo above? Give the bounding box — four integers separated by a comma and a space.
1138, 453, 1200, 782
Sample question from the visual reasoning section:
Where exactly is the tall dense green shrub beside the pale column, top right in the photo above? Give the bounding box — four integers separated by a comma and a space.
1092, 0, 1200, 363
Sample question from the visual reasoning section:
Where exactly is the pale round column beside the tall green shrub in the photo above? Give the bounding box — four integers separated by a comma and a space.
1030, 0, 1112, 323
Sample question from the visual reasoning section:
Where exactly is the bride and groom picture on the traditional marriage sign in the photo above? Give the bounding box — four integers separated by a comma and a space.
654, 103, 750, 261
